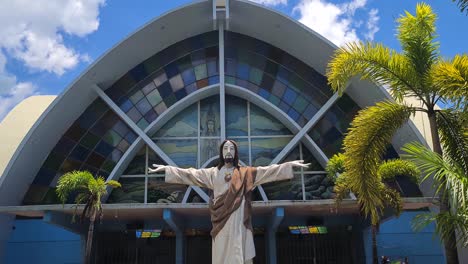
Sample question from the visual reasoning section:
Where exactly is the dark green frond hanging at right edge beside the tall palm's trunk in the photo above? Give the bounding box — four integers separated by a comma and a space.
437, 109, 468, 174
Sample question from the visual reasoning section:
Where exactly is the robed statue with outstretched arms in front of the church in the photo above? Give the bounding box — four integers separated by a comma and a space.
149, 140, 309, 264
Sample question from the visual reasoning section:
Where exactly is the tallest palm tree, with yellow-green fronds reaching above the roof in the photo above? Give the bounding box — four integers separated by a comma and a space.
327, 3, 468, 264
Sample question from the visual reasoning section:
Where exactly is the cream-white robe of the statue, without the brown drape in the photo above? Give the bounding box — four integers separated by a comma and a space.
166, 162, 293, 264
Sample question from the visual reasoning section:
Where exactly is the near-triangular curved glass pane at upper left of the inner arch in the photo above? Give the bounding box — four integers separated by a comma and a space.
154, 104, 198, 137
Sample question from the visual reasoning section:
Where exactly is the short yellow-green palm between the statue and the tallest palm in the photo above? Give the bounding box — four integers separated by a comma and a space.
326, 138, 420, 264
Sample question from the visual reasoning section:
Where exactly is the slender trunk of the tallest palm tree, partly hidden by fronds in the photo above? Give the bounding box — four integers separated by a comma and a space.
428, 110, 458, 264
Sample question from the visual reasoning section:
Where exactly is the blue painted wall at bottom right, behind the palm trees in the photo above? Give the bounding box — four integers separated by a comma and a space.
363, 212, 445, 264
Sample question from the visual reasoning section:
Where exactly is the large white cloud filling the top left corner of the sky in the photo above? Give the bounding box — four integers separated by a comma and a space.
0, 0, 105, 75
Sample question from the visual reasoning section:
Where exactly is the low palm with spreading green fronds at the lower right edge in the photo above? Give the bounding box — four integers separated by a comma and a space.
403, 111, 468, 246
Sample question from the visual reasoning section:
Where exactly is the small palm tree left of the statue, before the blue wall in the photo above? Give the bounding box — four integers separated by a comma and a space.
57, 171, 121, 264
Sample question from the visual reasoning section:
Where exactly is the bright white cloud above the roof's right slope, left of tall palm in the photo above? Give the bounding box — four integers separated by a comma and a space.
293, 0, 379, 46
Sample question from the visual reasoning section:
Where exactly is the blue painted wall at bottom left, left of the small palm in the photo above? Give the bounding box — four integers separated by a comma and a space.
0, 219, 82, 264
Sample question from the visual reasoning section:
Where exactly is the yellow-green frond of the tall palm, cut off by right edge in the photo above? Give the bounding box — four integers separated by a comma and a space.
431, 54, 468, 110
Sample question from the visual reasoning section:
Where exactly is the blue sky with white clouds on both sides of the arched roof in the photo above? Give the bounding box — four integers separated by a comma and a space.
0, 0, 468, 121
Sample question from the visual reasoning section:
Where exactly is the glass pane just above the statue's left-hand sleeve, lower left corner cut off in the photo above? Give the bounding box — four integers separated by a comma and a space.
156, 139, 197, 168
